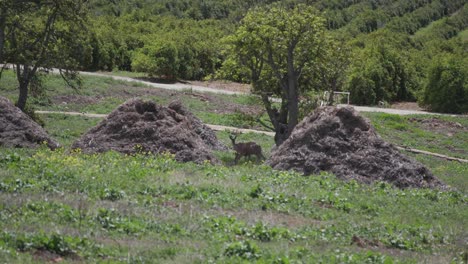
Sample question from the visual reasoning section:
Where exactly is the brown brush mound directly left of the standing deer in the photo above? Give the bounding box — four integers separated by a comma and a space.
72, 99, 223, 163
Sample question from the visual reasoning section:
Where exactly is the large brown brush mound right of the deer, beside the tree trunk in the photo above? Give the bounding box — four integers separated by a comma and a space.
267, 107, 444, 188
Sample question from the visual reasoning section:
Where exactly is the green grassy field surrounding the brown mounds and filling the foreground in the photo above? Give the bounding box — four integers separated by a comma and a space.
0, 71, 468, 263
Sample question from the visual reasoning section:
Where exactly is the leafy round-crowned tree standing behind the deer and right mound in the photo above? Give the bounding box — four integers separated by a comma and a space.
224, 4, 326, 145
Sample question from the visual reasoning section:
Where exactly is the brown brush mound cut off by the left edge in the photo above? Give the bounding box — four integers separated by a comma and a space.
0, 96, 59, 149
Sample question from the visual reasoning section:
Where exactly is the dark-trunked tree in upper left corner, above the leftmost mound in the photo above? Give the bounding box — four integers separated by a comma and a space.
0, 0, 88, 110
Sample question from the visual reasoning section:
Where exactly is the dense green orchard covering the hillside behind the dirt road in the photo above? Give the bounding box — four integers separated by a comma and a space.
0, 0, 468, 113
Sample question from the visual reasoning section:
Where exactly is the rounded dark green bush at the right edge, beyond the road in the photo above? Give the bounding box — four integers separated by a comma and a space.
422, 54, 468, 114
